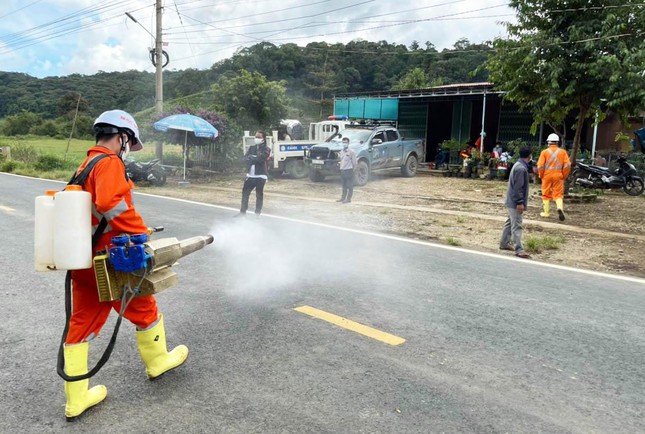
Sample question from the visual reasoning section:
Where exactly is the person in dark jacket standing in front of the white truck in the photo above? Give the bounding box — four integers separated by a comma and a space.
236, 131, 271, 217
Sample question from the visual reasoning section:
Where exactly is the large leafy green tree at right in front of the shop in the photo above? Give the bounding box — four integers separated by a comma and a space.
486, 0, 645, 161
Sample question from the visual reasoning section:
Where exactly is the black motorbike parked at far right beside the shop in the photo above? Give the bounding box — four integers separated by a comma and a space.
571, 156, 645, 196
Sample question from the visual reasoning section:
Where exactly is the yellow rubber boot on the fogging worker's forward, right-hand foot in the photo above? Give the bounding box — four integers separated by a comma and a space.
137, 315, 188, 380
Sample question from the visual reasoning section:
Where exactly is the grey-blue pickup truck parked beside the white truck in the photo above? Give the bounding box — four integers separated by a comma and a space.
305, 124, 425, 186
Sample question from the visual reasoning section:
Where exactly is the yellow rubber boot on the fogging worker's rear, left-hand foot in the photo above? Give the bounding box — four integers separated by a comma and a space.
63, 342, 107, 421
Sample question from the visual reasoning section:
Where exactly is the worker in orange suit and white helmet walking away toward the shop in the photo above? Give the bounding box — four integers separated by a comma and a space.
538, 133, 571, 221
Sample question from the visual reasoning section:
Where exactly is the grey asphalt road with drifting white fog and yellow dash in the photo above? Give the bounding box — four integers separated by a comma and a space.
0, 174, 645, 433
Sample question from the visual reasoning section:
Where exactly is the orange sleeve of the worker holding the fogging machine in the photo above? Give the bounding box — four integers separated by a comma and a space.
92, 157, 148, 234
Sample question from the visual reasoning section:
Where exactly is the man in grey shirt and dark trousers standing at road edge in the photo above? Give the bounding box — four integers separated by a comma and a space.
499, 148, 531, 259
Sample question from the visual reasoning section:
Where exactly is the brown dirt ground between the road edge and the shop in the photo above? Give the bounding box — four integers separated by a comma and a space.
137, 171, 645, 277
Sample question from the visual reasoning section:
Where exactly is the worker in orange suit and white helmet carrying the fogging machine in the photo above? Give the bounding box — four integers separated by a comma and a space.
63, 110, 188, 420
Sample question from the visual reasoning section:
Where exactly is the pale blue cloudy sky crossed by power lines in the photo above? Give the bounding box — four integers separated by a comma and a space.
0, 0, 514, 77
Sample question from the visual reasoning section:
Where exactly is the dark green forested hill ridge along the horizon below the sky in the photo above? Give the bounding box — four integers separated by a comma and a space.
0, 40, 490, 118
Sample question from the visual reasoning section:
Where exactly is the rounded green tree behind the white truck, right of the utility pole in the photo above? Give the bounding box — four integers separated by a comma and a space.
213, 69, 288, 130
